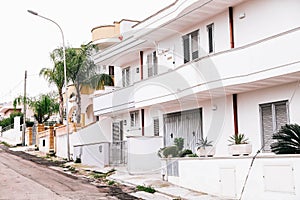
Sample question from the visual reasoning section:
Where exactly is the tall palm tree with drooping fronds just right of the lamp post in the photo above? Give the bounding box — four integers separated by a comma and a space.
66, 43, 114, 123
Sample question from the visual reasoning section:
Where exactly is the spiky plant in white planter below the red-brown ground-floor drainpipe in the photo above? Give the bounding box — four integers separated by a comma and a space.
228, 133, 252, 156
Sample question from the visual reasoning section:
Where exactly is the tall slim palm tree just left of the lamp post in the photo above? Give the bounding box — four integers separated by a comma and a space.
40, 48, 64, 124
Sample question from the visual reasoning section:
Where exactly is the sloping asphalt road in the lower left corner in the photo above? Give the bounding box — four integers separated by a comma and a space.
0, 145, 136, 200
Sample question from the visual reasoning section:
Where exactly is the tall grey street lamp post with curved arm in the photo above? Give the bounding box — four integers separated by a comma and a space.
27, 10, 70, 161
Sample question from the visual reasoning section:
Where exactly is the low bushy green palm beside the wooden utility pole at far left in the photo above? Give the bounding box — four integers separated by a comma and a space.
14, 94, 59, 124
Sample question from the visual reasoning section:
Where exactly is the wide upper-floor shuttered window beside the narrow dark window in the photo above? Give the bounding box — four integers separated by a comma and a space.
182, 30, 199, 63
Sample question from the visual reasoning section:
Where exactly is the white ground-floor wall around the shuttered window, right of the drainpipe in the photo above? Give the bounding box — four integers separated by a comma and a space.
237, 82, 300, 153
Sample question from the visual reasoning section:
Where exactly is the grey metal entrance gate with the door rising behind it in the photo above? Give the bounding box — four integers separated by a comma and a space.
110, 121, 127, 166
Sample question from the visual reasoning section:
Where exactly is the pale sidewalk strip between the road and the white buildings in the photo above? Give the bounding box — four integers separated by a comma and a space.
10, 146, 222, 200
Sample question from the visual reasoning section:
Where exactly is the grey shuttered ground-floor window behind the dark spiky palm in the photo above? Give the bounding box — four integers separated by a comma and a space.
260, 101, 288, 151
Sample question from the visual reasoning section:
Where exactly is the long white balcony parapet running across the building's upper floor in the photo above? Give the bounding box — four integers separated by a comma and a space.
94, 28, 300, 114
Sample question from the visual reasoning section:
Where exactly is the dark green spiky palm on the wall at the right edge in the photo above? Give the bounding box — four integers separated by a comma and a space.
271, 124, 300, 154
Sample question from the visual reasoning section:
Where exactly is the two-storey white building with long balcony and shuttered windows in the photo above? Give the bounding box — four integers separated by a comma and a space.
93, 0, 300, 199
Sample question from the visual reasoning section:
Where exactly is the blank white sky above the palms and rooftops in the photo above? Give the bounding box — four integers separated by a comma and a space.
0, 0, 175, 103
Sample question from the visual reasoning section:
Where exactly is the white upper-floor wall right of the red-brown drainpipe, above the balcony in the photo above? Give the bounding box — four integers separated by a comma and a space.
233, 0, 300, 47
